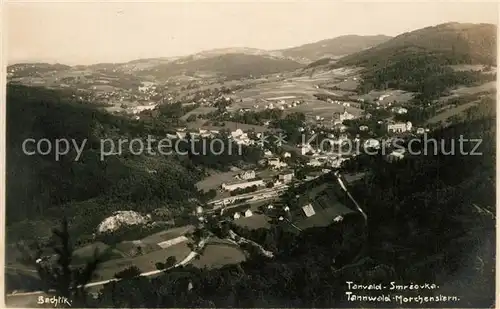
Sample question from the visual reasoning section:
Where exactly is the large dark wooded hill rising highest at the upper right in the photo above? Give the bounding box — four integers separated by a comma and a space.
334, 23, 496, 101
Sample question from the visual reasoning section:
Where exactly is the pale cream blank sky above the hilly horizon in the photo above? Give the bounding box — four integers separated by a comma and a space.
2, 0, 498, 65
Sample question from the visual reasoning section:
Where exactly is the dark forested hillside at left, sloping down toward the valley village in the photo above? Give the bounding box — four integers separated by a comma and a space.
6, 85, 260, 240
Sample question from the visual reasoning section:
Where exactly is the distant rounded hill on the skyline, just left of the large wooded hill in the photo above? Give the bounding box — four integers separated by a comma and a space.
279, 35, 391, 62
